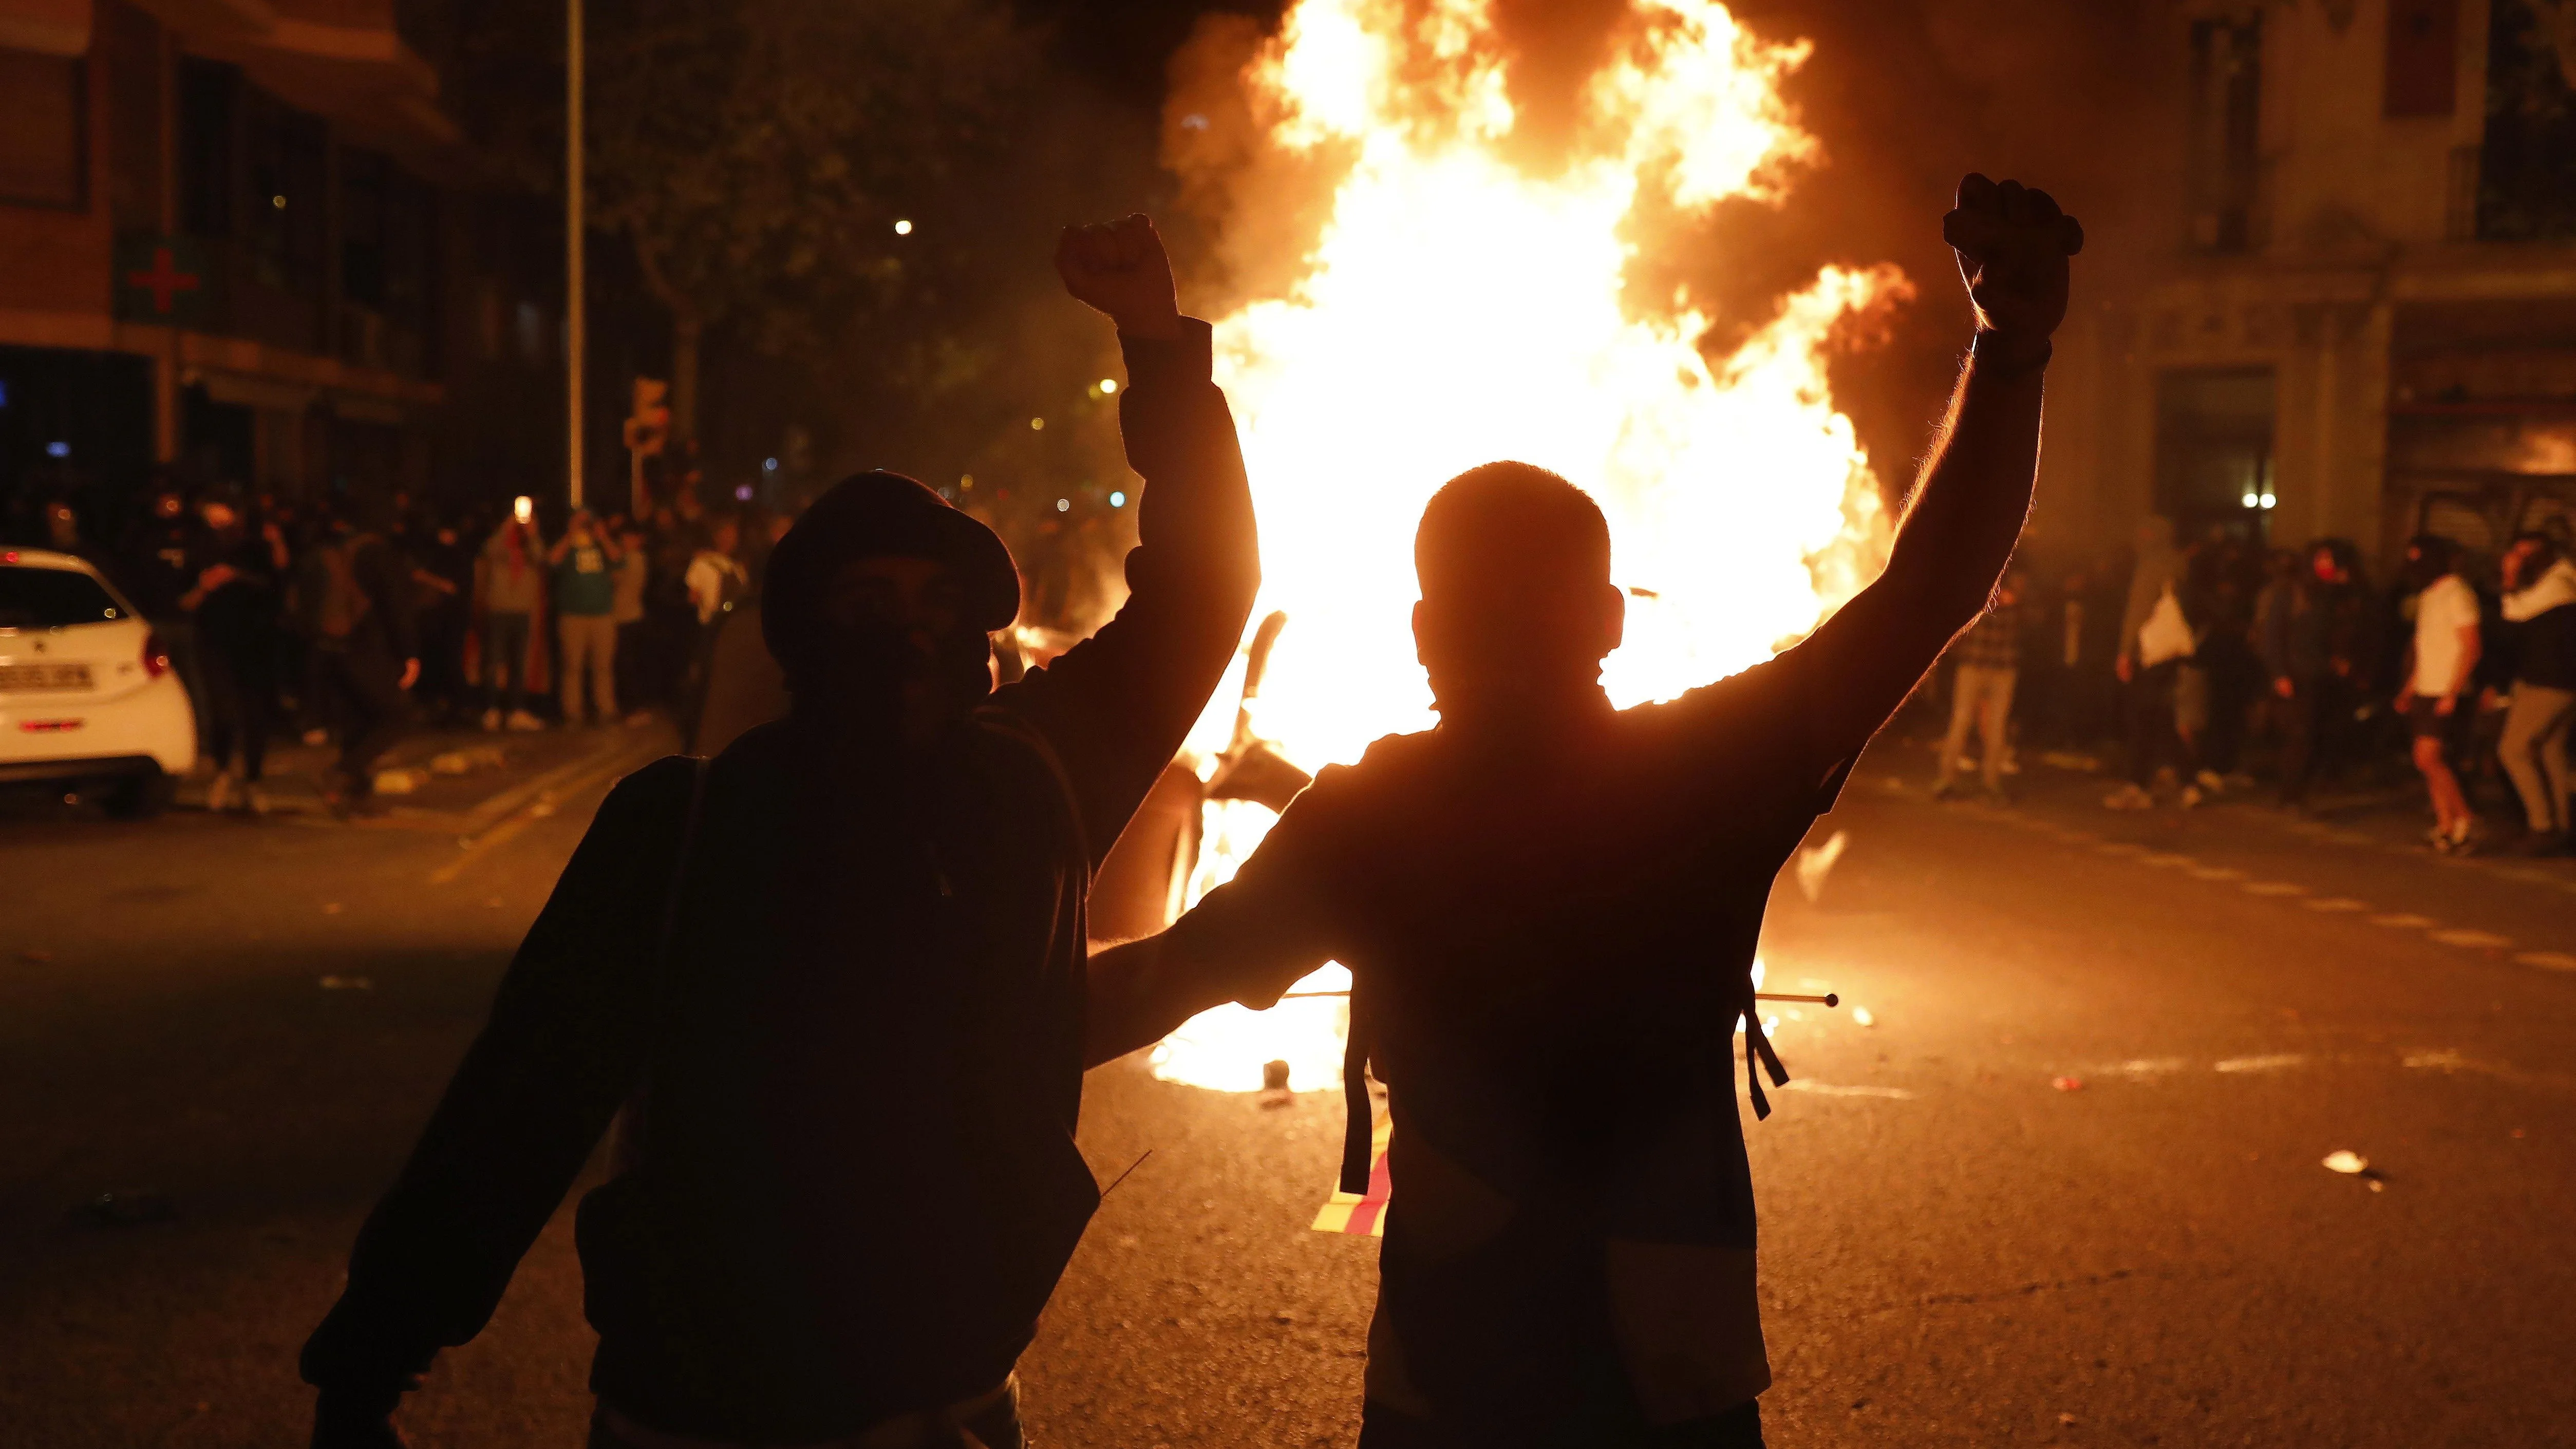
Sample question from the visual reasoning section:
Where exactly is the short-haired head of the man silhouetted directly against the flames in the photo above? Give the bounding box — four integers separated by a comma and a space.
1414, 463, 1628, 721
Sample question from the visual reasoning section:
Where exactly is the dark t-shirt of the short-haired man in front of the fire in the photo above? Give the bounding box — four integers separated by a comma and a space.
1175, 649, 1847, 1444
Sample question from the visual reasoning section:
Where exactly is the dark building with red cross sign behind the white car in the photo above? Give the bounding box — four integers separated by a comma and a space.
0, 0, 561, 533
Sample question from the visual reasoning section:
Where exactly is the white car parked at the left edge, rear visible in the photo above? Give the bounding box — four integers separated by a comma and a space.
0, 548, 196, 818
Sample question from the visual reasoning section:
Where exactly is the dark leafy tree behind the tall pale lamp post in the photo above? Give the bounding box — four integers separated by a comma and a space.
454, 0, 1041, 440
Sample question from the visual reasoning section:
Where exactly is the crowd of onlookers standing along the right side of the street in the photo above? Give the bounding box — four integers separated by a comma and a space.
1934, 517, 2576, 855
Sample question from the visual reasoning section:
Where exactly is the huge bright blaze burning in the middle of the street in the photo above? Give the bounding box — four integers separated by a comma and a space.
1154, 0, 1906, 1092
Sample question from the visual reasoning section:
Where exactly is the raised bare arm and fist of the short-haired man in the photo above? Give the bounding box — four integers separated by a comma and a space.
1800, 175, 2084, 759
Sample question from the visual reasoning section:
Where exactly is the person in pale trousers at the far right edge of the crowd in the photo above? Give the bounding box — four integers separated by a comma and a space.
2496, 533, 2576, 855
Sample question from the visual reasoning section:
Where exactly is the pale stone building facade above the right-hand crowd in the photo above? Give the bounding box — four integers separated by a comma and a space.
2043, 0, 2576, 579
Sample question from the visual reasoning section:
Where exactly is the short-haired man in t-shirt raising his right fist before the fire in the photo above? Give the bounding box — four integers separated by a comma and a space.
1089, 175, 2081, 1449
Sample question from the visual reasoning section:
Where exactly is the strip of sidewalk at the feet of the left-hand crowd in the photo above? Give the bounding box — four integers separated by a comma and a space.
173, 716, 678, 834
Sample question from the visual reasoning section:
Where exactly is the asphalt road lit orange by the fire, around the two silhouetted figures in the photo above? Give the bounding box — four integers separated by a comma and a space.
0, 739, 2576, 1449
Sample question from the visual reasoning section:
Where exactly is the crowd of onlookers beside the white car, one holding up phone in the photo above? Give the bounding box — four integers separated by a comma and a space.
13, 471, 788, 813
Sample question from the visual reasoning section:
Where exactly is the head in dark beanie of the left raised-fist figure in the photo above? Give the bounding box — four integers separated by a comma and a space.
760, 471, 1020, 739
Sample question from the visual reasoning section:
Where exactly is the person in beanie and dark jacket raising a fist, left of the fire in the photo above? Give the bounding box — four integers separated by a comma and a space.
304, 216, 1259, 1449
